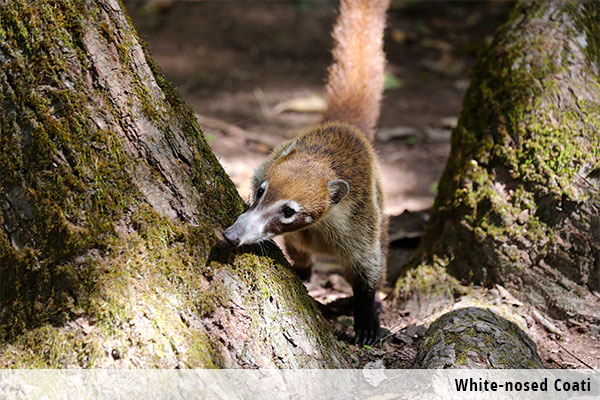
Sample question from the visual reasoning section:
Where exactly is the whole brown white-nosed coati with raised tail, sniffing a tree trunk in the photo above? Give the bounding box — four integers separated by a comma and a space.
224, 0, 389, 344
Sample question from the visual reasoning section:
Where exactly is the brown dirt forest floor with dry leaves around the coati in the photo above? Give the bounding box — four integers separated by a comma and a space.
125, 0, 600, 368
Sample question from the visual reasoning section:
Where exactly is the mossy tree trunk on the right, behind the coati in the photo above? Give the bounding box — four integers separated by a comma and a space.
398, 0, 600, 334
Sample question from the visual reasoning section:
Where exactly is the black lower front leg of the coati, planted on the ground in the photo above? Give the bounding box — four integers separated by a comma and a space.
352, 278, 379, 345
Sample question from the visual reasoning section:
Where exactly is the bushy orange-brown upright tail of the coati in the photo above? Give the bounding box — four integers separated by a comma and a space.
323, 0, 389, 141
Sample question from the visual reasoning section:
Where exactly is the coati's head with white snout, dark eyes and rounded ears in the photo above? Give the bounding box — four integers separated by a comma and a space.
223, 147, 349, 246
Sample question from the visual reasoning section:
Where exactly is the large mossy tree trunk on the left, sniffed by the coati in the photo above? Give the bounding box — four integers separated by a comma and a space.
0, 0, 345, 368
